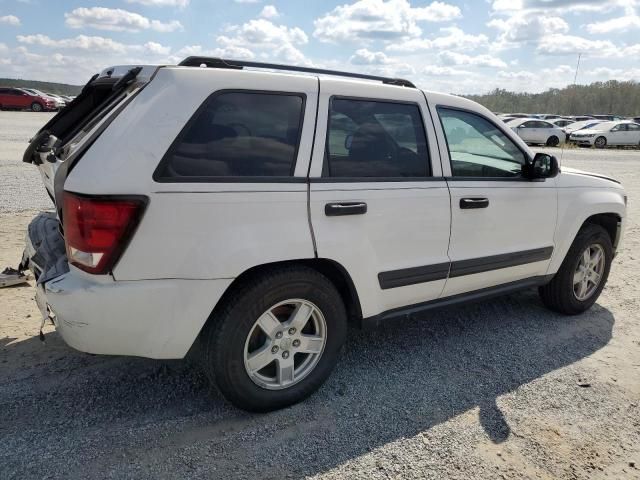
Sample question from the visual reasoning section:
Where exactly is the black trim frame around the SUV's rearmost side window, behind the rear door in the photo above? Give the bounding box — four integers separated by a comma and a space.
151, 89, 307, 183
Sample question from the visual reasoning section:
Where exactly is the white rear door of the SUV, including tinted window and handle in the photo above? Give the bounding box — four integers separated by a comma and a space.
309, 79, 450, 317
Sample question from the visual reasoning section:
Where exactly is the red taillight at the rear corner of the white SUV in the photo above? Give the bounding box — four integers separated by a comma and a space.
62, 192, 147, 274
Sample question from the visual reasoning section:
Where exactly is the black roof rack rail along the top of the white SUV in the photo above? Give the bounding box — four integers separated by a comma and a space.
178, 57, 416, 88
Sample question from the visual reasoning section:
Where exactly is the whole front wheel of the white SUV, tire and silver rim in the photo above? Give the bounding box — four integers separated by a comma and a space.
539, 224, 613, 315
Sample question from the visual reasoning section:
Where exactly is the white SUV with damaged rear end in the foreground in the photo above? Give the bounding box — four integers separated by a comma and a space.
23, 58, 626, 411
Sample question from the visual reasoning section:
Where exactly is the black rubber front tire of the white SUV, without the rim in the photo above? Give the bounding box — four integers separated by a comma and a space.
538, 224, 613, 315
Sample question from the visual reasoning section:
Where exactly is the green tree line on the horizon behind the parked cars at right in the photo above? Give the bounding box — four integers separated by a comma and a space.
463, 80, 640, 116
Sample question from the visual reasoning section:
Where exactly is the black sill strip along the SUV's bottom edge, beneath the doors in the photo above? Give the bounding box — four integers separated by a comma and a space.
360, 275, 553, 330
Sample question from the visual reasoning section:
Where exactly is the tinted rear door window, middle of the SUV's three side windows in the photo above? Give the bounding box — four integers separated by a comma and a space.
324, 98, 430, 178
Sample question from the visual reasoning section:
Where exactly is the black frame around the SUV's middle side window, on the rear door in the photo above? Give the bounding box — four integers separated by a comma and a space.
318, 95, 436, 183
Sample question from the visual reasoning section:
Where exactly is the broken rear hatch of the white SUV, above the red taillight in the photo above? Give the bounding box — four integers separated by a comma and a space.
22, 65, 159, 220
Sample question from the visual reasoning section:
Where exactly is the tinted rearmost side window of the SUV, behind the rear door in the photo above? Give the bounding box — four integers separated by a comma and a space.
155, 91, 305, 181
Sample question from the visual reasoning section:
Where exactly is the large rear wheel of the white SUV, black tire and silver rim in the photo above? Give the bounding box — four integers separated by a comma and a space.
200, 266, 347, 412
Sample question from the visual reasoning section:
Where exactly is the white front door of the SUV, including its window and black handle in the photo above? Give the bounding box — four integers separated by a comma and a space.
430, 102, 557, 296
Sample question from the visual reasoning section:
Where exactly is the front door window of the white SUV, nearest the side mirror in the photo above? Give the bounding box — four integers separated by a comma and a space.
438, 107, 525, 177
